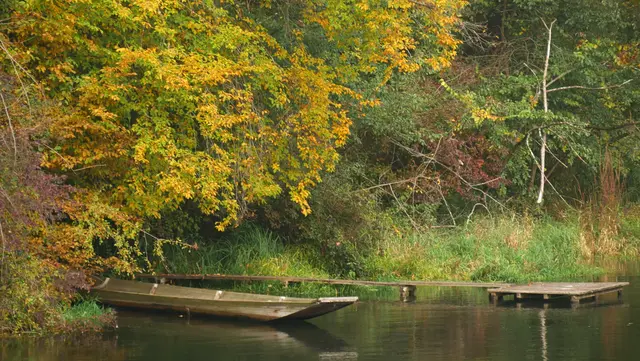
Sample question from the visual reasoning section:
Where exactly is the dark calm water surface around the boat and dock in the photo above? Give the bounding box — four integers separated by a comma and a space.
0, 272, 640, 361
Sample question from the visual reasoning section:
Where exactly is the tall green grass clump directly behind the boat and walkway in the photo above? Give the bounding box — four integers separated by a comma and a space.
156, 225, 378, 297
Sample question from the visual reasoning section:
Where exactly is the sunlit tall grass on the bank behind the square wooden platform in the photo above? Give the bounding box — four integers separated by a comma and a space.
367, 218, 603, 283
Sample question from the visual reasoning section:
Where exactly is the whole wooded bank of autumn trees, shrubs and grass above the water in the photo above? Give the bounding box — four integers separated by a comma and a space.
0, 0, 640, 334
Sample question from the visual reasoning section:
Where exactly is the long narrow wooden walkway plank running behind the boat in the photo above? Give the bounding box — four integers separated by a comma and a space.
136, 273, 511, 288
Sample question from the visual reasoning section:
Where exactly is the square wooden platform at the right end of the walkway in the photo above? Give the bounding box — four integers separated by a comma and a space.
487, 282, 629, 303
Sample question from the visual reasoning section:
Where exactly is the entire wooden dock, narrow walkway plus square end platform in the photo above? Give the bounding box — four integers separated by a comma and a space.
136, 273, 629, 304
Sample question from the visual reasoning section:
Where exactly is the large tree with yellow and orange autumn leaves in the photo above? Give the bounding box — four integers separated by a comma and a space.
0, 0, 464, 272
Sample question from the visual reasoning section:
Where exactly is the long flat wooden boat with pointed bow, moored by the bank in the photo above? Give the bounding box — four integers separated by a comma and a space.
91, 278, 358, 321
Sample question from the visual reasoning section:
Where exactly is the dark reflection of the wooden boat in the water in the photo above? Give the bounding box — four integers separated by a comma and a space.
117, 311, 357, 360
